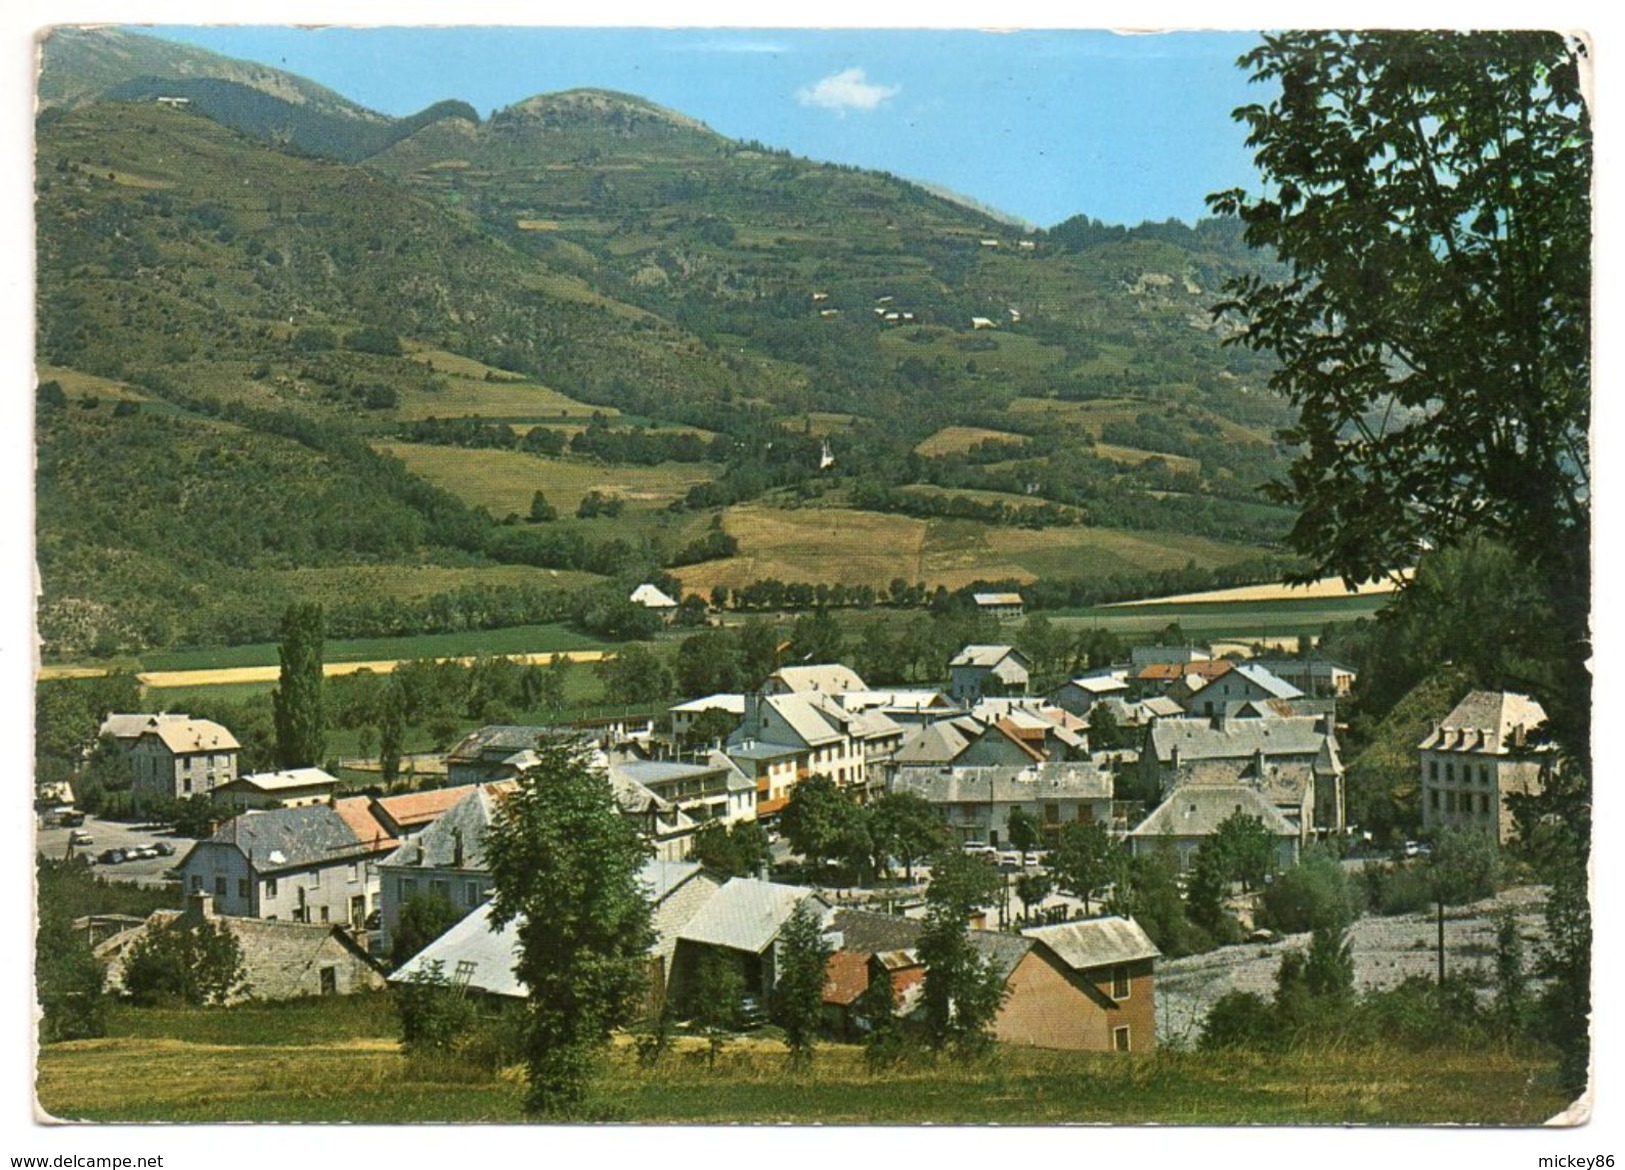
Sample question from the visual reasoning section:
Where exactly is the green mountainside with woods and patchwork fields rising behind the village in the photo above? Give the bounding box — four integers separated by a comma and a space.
37, 33, 1292, 655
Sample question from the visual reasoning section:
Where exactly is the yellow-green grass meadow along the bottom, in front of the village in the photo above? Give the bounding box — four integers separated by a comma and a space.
37, 996, 1567, 1125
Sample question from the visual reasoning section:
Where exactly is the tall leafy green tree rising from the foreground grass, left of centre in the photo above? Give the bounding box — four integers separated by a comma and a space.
486, 739, 652, 1118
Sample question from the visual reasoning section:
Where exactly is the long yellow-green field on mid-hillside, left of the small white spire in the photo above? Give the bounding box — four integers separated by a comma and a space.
377, 444, 718, 518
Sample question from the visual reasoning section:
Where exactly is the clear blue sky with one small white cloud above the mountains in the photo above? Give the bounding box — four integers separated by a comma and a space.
141, 26, 1258, 226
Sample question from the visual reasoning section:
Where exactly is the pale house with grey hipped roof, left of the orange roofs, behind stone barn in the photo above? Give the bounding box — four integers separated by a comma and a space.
180, 804, 379, 930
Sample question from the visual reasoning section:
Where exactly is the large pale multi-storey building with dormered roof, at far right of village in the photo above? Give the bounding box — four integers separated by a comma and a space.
1417, 691, 1555, 842
